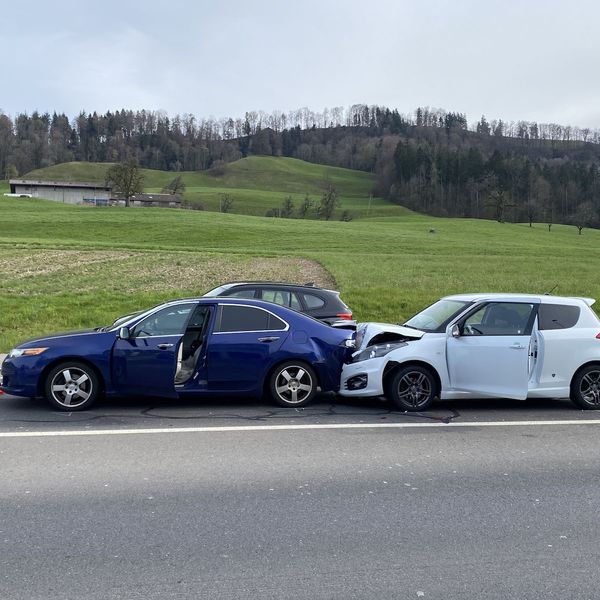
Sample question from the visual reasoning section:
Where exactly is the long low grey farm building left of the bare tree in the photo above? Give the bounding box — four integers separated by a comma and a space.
8, 179, 112, 204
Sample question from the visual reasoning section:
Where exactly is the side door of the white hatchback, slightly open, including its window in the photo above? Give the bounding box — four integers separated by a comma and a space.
446, 300, 539, 400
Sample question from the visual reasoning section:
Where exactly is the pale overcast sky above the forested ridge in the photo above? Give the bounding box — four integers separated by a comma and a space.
0, 0, 600, 127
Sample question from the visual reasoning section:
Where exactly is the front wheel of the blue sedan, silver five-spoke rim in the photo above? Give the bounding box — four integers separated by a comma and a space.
44, 361, 100, 412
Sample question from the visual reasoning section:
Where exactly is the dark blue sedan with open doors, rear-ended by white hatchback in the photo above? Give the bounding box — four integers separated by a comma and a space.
0, 298, 352, 411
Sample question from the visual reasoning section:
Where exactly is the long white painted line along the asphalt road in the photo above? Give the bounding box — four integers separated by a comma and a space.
0, 419, 600, 438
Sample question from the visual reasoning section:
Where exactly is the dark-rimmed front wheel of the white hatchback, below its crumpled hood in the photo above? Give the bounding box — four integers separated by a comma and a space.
386, 365, 438, 412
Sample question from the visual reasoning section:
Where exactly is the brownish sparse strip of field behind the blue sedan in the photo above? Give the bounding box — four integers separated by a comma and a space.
0, 250, 335, 295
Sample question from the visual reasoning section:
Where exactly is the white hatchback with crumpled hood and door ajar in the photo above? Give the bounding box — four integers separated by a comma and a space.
340, 294, 600, 411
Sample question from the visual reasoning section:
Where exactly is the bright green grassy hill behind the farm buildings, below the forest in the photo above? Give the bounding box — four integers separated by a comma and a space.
25, 156, 407, 218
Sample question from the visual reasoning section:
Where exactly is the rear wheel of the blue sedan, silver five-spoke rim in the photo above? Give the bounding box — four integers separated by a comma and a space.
269, 360, 317, 408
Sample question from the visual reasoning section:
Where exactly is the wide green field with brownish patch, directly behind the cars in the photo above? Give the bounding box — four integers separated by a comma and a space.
0, 197, 600, 351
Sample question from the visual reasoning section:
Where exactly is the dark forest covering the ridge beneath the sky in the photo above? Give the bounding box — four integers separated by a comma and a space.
0, 104, 600, 231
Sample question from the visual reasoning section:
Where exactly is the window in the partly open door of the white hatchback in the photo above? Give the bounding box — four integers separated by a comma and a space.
462, 302, 535, 336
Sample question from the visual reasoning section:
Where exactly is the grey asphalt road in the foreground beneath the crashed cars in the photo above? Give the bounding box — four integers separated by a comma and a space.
0, 396, 600, 600
